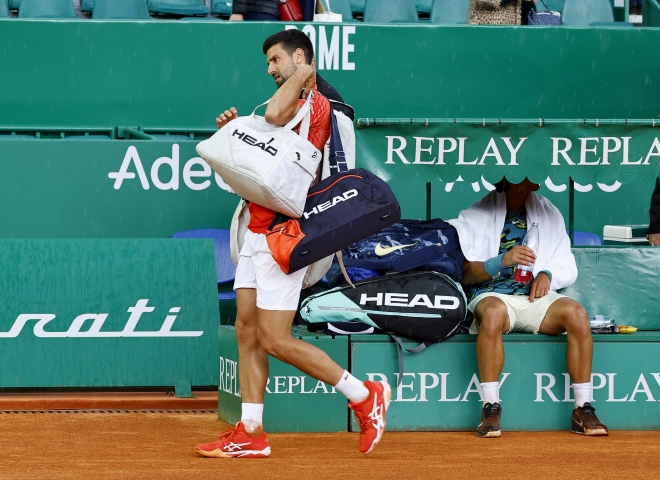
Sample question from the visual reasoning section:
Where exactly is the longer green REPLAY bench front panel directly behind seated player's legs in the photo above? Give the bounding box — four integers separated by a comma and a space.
351, 334, 660, 431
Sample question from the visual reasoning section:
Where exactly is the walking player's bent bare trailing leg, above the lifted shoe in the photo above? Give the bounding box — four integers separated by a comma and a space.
257, 308, 344, 384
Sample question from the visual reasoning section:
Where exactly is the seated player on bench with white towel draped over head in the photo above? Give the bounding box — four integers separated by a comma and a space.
449, 179, 608, 437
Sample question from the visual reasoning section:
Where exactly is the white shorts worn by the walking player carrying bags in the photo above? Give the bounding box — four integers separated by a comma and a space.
234, 230, 308, 310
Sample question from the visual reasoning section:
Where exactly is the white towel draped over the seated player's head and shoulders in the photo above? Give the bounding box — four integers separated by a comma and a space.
449, 192, 578, 291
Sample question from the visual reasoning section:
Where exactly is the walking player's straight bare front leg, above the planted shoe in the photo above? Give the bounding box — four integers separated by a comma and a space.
235, 288, 268, 404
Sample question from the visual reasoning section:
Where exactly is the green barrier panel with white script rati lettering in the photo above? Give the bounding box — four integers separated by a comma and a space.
0, 239, 219, 390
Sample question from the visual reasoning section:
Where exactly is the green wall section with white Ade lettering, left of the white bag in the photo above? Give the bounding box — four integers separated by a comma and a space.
0, 140, 238, 238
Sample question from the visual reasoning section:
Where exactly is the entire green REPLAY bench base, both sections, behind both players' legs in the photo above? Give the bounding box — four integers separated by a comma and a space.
218, 327, 660, 432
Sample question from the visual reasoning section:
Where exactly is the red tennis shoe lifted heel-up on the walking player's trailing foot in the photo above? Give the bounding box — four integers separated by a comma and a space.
348, 381, 392, 454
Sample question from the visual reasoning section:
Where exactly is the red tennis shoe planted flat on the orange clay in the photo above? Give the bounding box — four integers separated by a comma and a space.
195, 422, 270, 458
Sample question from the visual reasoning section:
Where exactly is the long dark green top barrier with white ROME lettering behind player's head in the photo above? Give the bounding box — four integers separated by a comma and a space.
0, 20, 660, 128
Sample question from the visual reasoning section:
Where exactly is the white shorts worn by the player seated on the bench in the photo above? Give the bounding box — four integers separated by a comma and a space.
468, 292, 566, 334
